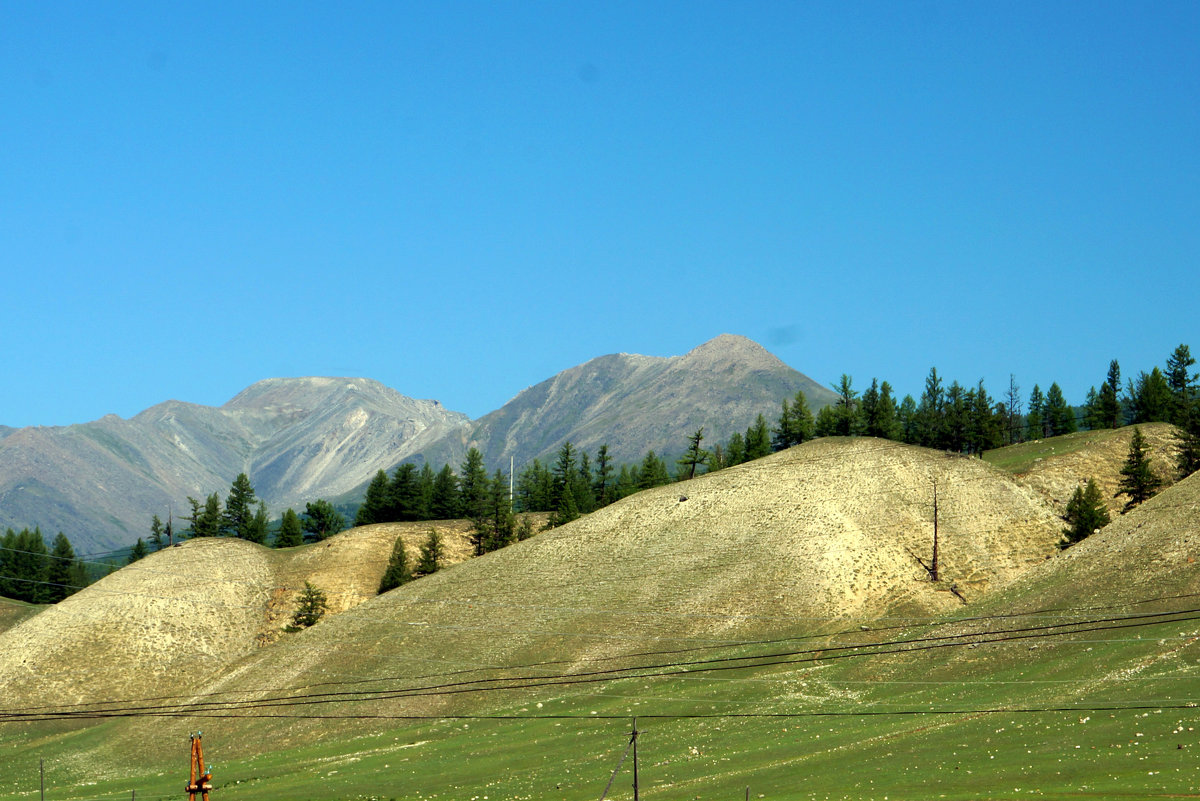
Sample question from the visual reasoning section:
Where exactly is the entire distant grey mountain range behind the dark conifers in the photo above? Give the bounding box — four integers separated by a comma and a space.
0, 335, 834, 552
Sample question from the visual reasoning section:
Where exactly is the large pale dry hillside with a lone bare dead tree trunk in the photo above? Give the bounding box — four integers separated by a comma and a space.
96, 439, 1060, 747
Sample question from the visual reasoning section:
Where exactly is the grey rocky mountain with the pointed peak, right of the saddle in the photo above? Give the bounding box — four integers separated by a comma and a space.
410, 335, 836, 470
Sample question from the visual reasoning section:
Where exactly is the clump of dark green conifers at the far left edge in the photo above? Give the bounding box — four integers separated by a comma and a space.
0, 528, 90, 603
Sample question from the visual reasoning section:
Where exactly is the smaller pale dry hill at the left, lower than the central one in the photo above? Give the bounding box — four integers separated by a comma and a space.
0, 522, 470, 706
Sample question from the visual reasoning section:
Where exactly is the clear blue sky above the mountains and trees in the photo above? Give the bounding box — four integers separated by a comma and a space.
0, 1, 1200, 426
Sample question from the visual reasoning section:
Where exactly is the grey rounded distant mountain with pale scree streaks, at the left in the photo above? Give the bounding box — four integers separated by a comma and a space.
0, 378, 468, 552
